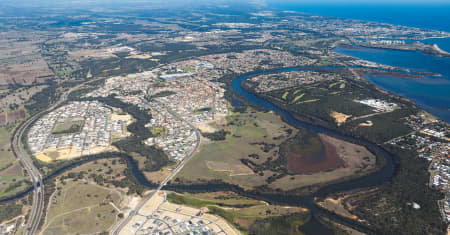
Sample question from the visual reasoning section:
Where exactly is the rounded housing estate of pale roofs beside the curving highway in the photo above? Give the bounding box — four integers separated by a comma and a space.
27, 101, 129, 160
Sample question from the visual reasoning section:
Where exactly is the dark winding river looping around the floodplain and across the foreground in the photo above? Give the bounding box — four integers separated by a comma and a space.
2, 67, 395, 235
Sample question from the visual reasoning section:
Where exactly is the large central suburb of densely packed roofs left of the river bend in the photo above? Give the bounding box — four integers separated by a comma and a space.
87, 60, 228, 161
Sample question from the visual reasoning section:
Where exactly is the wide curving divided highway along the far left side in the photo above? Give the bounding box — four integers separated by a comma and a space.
11, 78, 103, 235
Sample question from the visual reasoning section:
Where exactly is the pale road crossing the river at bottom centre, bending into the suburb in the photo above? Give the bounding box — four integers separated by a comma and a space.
112, 101, 200, 235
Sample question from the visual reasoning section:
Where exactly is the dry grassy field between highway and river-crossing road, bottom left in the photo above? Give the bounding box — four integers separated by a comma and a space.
44, 181, 121, 234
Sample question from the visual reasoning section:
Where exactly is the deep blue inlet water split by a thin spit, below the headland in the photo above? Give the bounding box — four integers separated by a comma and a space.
333, 47, 450, 123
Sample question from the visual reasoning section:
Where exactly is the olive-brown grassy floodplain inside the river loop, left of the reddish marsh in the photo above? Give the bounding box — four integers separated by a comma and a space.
178, 112, 295, 188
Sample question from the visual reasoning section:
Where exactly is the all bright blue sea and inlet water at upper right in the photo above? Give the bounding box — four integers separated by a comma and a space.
269, 0, 450, 123
